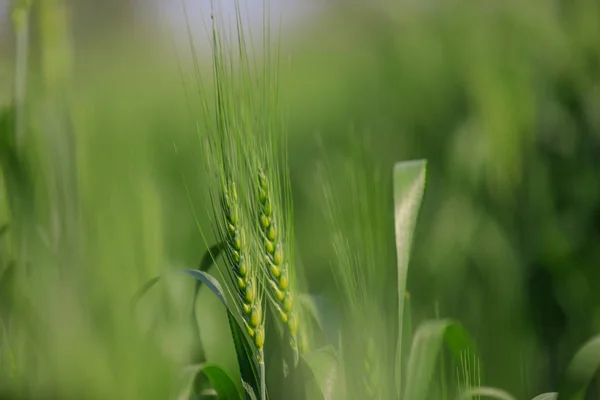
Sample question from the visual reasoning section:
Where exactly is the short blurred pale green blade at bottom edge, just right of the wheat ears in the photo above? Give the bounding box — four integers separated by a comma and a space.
302, 346, 339, 400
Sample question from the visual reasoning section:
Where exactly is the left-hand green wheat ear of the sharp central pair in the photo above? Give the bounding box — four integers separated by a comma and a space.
221, 183, 265, 361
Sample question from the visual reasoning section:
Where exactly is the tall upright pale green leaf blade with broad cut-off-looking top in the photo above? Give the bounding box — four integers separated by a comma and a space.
394, 160, 427, 397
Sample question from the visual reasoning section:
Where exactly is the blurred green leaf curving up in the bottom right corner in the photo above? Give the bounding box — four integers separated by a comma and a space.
558, 335, 600, 400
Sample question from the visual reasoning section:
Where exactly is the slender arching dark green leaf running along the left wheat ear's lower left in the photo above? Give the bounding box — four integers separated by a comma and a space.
183, 269, 260, 400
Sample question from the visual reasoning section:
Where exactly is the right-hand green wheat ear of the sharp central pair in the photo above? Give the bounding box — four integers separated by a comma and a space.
257, 168, 298, 351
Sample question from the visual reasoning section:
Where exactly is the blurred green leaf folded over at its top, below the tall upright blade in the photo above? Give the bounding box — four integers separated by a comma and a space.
402, 320, 472, 400
